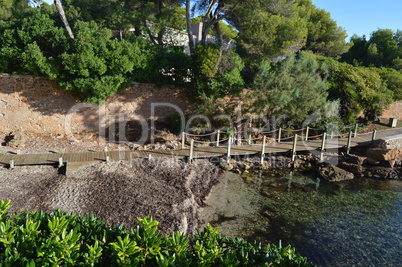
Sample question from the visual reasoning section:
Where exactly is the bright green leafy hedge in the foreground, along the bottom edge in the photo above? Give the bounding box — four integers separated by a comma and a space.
0, 200, 313, 266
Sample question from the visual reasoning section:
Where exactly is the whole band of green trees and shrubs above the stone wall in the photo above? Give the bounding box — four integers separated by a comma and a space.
0, 0, 402, 128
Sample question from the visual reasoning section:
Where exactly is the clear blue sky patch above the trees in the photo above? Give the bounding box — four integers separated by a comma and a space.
313, 0, 402, 38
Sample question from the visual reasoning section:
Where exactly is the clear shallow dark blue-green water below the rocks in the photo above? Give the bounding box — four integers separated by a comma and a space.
207, 172, 402, 266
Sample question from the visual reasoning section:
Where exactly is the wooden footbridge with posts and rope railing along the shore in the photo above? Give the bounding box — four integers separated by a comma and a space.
0, 128, 402, 173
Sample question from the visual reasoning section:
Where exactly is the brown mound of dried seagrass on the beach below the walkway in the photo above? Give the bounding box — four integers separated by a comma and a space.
0, 159, 222, 234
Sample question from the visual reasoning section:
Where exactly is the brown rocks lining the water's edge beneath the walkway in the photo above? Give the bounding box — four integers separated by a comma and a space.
220, 148, 402, 182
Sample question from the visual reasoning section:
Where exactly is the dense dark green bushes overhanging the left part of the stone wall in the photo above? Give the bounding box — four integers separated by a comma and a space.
0, 10, 153, 103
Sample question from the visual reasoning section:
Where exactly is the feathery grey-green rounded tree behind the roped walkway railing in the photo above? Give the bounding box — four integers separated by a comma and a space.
250, 52, 328, 128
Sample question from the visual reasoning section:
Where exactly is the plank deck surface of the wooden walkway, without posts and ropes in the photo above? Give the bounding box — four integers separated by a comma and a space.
0, 128, 402, 166
